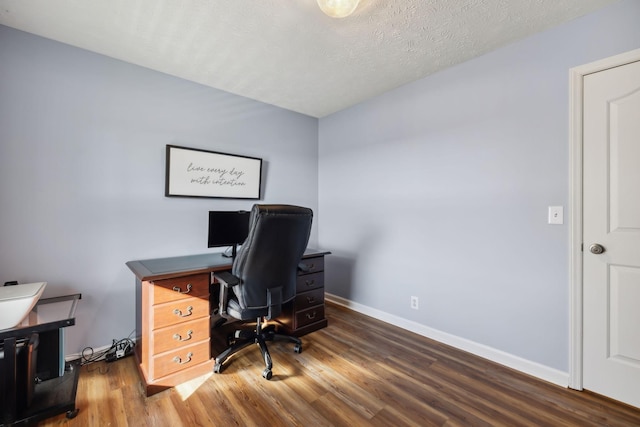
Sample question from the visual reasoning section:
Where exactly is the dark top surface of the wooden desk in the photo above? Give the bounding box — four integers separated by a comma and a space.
126, 248, 330, 280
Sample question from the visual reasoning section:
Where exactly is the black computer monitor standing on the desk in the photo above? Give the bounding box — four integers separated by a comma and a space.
208, 211, 251, 258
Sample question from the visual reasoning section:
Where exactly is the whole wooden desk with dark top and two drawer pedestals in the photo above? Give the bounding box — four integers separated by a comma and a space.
126, 249, 329, 396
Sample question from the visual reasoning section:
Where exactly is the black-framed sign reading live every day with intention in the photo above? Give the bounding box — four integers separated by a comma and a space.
164, 145, 262, 199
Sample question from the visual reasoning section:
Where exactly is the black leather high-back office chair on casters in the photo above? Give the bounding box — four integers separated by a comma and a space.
213, 205, 313, 380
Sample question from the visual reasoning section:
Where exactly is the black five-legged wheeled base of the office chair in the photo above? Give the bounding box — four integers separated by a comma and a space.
213, 317, 302, 380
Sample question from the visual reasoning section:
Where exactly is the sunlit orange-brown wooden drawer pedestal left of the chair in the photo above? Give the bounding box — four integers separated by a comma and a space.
136, 273, 212, 395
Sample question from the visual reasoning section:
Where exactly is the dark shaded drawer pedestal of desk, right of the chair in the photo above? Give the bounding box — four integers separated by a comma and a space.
276, 254, 327, 336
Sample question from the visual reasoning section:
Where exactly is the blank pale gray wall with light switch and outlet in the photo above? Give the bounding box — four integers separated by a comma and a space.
319, 0, 640, 372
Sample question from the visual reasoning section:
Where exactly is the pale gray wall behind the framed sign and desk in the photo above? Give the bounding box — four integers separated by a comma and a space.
0, 26, 318, 353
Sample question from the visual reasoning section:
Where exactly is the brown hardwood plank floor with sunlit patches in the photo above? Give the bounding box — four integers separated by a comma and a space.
39, 304, 640, 427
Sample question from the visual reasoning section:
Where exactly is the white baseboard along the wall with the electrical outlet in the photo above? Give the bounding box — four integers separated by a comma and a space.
325, 293, 569, 387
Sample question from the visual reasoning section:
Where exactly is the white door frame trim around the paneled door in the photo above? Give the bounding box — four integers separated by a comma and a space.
569, 49, 640, 390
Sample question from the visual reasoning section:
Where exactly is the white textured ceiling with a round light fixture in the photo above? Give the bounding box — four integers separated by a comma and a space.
0, 0, 617, 117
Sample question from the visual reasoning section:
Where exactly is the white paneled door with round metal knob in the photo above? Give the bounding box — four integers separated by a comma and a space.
583, 57, 640, 407
